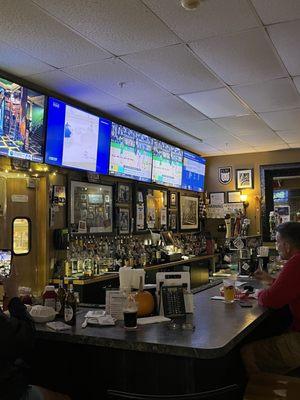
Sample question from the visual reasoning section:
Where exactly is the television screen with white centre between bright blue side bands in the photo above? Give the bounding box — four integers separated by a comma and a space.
45, 97, 111, 174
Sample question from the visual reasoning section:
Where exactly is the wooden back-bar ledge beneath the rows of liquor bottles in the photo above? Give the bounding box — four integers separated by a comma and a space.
50, 254, 218, 285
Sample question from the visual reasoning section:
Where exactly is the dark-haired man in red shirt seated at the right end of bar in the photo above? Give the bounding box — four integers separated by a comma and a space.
241, 222, 300, 375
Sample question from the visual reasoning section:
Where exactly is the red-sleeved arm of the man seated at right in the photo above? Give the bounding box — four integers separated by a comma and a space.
258, 260, 300, 308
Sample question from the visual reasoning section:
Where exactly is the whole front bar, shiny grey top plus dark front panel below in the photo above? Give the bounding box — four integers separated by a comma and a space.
33, 286, 276, 399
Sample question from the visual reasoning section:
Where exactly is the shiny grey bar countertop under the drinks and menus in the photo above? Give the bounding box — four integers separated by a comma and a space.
36, 285, 269, 359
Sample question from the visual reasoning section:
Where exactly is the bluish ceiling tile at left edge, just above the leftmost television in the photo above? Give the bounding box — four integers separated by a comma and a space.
0, 41, 54, 77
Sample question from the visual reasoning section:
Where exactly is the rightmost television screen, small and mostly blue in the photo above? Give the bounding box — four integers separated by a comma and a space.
181, 151, 206, 192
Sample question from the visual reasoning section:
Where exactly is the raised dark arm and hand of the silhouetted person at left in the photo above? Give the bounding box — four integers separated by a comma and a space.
0, 269, 35, 359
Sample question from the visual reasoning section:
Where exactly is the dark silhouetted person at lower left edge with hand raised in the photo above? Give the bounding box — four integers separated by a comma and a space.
0, 268, 69, 400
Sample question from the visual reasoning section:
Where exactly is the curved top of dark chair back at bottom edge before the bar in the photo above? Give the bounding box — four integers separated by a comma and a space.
107, 384, 240, 400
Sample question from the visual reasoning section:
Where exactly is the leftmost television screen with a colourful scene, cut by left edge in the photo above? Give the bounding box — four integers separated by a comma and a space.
0, 78, 45, 162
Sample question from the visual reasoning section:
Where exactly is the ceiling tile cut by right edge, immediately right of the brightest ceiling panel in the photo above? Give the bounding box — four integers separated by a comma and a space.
232, 78, 300, 112
